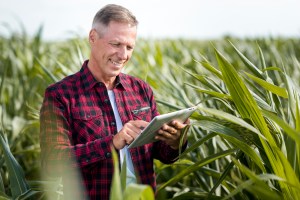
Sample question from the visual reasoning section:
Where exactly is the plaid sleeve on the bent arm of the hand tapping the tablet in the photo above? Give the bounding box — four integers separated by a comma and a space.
40, 90, 112, 176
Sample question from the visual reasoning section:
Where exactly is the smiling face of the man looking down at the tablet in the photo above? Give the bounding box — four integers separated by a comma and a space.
89, 21, 137, 81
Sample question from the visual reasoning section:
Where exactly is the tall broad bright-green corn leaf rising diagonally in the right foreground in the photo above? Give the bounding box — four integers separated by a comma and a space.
215, 50, 300, 198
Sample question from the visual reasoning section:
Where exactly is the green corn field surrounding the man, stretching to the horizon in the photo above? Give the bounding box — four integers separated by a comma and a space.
0, 25, 300, 200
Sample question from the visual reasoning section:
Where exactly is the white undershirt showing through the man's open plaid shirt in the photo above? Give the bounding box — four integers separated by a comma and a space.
108, 90, 136, 185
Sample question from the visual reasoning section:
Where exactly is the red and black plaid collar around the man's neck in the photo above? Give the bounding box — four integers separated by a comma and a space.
80, 60, 129, 90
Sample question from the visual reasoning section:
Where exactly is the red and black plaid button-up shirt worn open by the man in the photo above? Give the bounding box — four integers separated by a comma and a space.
40, 61, 183, 199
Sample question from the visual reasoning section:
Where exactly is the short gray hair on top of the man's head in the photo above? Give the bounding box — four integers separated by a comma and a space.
92, 4, 138, 29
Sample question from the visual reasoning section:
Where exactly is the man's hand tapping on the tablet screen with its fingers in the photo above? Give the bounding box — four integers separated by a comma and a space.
113, 120, 149, 150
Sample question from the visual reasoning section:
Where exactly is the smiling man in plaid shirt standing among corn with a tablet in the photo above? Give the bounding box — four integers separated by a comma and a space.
40, 4, 186, 199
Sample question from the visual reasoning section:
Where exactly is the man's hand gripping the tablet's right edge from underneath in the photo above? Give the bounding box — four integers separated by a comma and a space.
155, 119, 190, 150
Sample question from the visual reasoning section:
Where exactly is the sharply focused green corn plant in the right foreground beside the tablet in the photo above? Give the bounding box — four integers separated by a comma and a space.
152, 41, 300, 199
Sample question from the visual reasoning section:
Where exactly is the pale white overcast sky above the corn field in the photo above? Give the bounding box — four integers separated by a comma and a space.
0, 0, 300, 40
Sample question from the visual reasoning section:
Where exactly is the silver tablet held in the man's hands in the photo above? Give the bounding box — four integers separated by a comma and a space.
128, 107, 197, 148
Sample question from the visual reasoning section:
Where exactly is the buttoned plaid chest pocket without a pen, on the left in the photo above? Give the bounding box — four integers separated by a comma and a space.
72, 108, 105, 143
